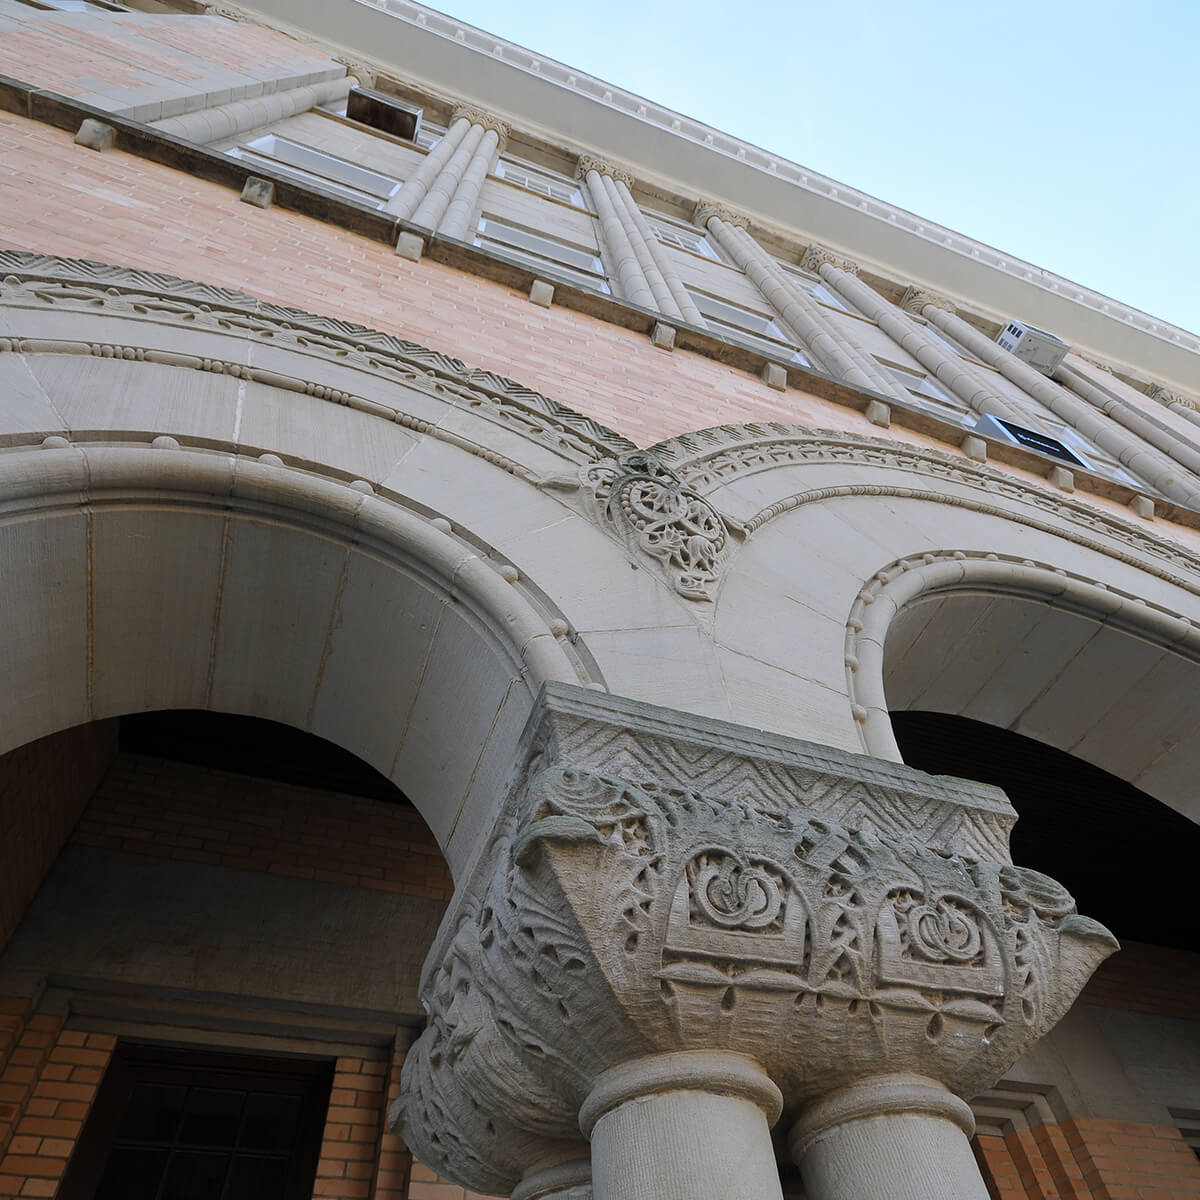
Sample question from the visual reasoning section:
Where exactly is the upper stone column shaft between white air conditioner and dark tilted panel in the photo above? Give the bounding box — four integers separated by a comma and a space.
923, 305, 1200, 508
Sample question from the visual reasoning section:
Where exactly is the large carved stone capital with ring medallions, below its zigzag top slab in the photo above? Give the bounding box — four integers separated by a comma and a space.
397, 766, 1116, 1192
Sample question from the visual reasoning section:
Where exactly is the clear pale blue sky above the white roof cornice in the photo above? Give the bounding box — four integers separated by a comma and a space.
434, 0, 1200, 331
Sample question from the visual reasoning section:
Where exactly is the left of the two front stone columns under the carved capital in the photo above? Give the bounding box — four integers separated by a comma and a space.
580, 1051, 782, 1200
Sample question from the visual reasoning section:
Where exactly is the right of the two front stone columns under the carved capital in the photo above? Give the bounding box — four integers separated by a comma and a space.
791, 1075, 988, 1200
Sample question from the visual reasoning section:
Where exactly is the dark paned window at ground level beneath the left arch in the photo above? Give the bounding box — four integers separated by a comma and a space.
59, 1043, 332, 1200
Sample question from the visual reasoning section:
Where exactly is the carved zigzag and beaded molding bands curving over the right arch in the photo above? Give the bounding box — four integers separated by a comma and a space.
653, 422, 1200, 595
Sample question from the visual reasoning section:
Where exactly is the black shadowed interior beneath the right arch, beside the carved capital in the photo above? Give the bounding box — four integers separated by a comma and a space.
890, 712, 1200, 950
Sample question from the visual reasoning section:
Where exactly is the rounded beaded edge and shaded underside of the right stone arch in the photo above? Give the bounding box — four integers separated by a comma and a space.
846, 551, 1200, 820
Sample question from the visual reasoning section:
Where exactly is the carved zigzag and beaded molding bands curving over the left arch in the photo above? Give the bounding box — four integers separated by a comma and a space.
0, 250, 634, 466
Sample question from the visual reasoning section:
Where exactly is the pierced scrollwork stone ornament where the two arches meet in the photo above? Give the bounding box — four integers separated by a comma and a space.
583, 451, 730, 600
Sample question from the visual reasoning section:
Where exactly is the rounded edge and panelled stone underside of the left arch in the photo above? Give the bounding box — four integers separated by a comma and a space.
0, 439, 581, 862
